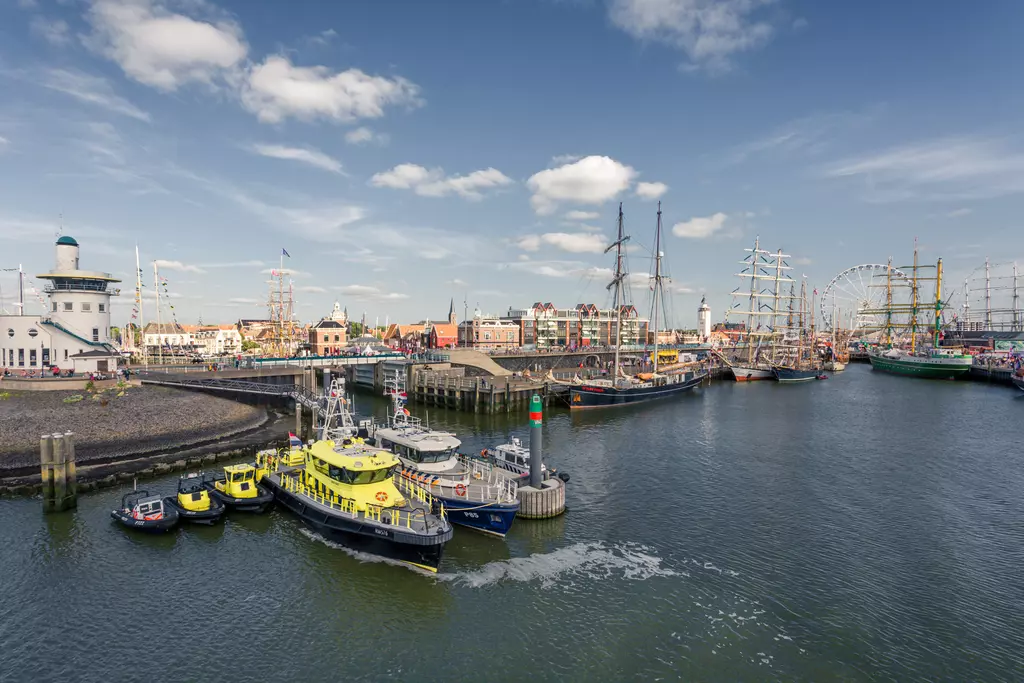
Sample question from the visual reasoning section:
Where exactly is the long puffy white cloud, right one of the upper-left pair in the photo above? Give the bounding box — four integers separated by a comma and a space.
242, 55, 421, 123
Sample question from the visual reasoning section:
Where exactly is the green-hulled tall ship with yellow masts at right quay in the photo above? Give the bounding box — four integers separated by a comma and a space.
867, 246, 974, 379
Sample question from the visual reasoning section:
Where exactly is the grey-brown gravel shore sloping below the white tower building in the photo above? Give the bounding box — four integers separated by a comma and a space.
0, 386, 267, 476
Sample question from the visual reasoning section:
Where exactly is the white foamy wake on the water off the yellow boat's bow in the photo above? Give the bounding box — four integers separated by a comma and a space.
437, 543, 678, 588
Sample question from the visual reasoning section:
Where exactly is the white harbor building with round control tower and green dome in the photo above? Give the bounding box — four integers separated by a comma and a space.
0, 236, 121, 376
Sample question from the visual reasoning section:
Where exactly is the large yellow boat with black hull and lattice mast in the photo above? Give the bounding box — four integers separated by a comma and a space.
257, 380, 453, 571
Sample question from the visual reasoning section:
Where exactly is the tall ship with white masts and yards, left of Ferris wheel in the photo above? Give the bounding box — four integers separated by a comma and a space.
726, 237, 793, 382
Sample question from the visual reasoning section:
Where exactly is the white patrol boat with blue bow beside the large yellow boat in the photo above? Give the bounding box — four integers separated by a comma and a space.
359, 373, 519, 538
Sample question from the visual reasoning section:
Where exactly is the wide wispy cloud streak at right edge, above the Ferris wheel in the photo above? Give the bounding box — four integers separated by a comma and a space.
824, 136, 1024, 202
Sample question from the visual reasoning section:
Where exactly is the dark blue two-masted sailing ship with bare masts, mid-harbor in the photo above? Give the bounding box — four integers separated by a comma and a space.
569, 202, 708, 410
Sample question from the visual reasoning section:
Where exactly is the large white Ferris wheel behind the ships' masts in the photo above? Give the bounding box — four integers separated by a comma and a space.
820, 263, 906, 331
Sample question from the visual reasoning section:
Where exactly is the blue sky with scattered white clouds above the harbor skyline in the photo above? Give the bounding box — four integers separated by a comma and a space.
0, 0, 1024, 327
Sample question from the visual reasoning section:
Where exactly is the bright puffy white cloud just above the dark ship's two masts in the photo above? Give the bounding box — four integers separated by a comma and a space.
526, 156, 637, 215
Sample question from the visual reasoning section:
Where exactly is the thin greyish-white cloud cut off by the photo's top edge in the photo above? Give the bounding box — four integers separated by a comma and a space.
608, 0, 774, 74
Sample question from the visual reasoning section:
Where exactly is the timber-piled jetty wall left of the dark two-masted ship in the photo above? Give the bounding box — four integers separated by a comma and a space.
409, 372, 555, 413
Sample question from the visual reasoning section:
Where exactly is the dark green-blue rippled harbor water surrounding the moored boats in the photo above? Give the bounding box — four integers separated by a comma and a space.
0, 366, 1024, 682
